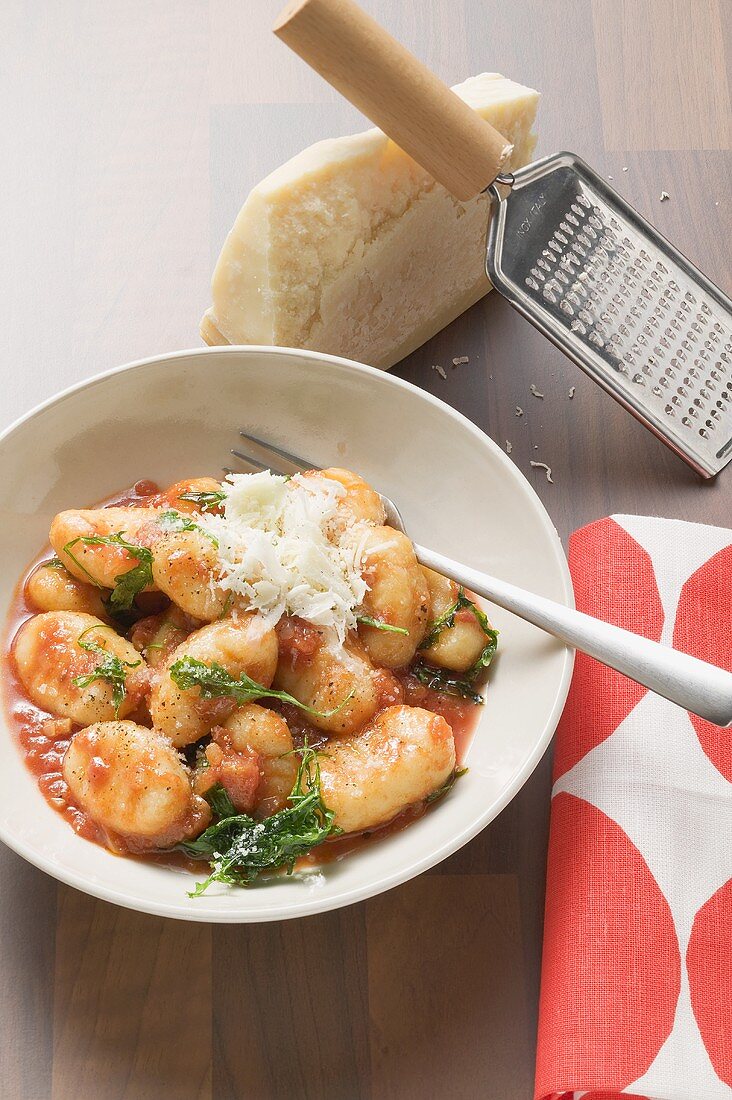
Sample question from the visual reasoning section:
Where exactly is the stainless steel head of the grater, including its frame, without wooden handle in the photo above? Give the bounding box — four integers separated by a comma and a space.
485, 153, 732, 477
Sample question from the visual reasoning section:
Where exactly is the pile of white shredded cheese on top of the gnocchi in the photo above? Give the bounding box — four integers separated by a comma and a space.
201, 471, 368, 644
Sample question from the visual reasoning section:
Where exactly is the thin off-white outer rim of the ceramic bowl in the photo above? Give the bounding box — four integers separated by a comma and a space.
0, 344, 575, 924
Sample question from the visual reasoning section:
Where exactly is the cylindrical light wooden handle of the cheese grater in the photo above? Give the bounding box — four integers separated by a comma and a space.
273, 0, 513, 200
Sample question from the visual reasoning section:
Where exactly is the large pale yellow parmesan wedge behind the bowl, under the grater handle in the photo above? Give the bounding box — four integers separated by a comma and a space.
200, 73, 539, 367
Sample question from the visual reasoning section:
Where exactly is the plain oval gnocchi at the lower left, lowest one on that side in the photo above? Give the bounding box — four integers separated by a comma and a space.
64, 722, 210, 851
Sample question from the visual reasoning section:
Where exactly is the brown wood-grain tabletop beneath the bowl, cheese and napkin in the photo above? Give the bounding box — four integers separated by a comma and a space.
0, 0, 732, 1100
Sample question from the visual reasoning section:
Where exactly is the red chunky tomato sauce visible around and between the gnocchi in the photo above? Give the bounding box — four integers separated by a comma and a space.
0, 480, 488, 878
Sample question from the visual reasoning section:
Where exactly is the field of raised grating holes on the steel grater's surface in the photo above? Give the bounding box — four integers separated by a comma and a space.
518, 185, 732, 464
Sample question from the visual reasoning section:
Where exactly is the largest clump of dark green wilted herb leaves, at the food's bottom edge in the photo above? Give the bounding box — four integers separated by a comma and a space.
177, 743, 341, 898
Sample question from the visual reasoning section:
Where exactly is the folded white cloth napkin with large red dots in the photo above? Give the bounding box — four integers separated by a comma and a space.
536, 516, 732, 1100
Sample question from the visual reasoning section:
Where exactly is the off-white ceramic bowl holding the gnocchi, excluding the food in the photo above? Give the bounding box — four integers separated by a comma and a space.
0, 348, 572, 923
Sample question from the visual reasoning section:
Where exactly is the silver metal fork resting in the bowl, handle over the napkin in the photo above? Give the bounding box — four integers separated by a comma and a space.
230, 431, 732, 726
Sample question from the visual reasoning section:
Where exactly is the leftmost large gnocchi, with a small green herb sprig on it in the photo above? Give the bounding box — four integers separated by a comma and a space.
13, 612, 146, 725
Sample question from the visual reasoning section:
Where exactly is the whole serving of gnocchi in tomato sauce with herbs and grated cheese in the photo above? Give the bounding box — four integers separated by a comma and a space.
4, 466, 494, 894
